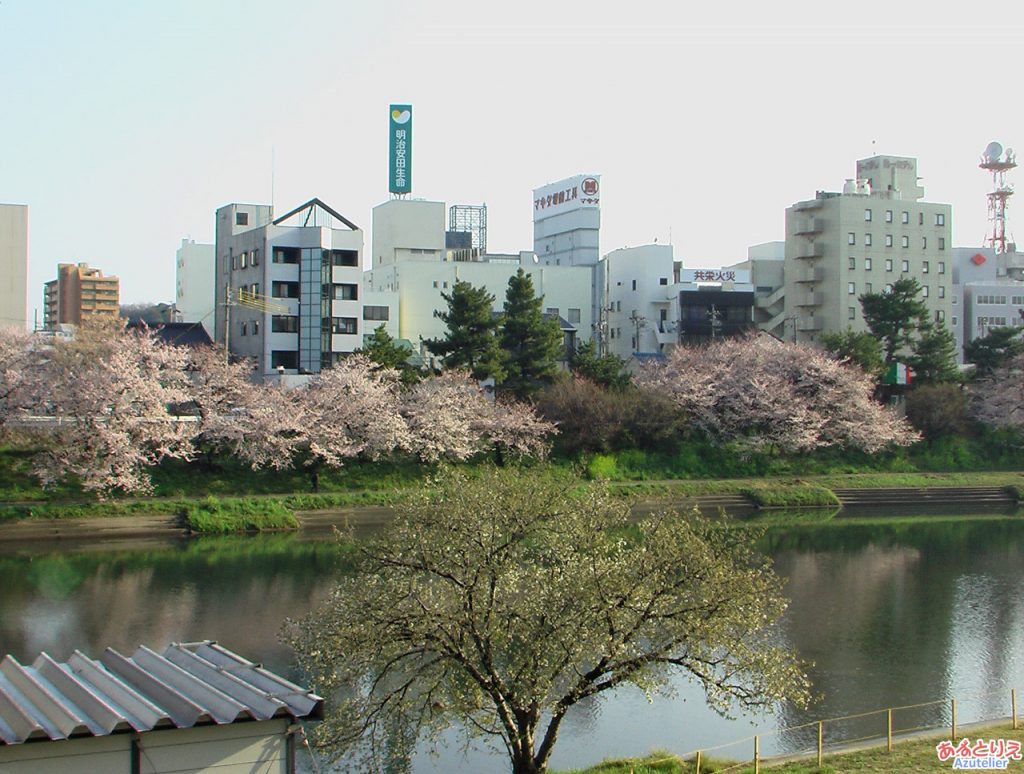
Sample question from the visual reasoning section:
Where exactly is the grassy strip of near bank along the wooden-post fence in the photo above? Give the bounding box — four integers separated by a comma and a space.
552, 724, 1024, 774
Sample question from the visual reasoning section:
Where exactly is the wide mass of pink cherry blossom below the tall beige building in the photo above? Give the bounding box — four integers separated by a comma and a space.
637, 335, 919, 454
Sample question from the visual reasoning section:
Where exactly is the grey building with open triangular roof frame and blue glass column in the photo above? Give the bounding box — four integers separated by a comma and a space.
214, 199, 364, 378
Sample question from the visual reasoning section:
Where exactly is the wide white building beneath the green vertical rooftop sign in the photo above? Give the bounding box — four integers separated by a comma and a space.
362, 200, 598, 364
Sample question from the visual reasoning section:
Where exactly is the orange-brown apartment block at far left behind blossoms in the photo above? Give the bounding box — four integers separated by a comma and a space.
43, 263, 121, 331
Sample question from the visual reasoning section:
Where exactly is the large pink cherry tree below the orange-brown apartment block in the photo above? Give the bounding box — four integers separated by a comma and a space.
35, 330, 193, 496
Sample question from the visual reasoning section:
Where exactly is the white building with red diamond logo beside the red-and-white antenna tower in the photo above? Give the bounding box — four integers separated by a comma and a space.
952, 246, 1024, 360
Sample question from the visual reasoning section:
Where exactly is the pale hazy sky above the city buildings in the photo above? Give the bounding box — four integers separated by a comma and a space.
0, 0, 1024, 315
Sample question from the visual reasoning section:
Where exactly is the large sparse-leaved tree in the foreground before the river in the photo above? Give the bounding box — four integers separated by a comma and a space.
288, 469, 808, 774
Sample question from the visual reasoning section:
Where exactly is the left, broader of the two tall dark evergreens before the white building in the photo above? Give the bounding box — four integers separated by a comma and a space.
424, 280, 502, 381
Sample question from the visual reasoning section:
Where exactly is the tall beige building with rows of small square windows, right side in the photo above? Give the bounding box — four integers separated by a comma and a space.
775, 156, 953, 341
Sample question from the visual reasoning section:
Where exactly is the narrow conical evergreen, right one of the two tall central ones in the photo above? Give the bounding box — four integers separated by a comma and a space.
500, 268, 562, 398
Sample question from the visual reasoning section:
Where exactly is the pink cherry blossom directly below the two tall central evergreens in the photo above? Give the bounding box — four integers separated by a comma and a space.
401, 370, 555, 463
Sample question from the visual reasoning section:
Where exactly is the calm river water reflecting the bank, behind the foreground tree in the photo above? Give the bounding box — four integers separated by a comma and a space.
0, 517, 1024, 774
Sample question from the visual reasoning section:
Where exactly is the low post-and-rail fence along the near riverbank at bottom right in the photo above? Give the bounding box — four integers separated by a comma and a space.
682, 688, 1019, 774
